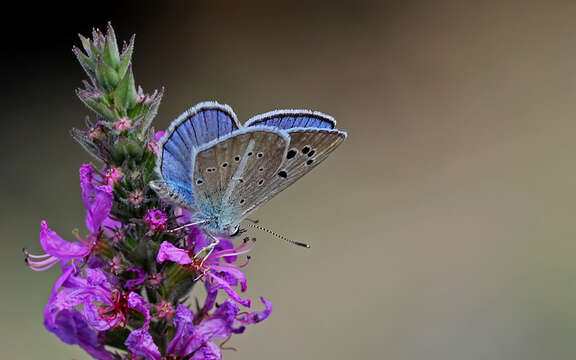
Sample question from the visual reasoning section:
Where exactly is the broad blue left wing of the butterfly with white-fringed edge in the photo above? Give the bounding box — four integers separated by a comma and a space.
152, 102, 241, 208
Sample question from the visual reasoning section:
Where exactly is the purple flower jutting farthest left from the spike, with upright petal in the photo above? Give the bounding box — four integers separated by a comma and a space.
26, 164, 118, 271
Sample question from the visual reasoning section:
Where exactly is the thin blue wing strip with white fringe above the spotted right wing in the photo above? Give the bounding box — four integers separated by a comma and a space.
244, 110, 336, 129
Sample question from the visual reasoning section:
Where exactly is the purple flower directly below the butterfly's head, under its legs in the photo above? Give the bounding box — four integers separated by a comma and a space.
156, 236, 252, 307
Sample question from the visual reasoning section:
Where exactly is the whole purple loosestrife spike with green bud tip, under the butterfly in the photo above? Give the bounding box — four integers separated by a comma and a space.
26, 26, 272, 360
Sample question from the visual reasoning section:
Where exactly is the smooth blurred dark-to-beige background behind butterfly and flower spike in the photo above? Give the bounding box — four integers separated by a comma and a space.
0, 0, 576, 360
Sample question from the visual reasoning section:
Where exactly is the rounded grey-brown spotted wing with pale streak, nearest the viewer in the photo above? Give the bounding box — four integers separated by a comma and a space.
193, 127, 289, 224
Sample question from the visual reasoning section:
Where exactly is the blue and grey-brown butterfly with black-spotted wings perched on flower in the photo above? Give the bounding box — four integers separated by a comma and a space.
150, 102, 347, 248
